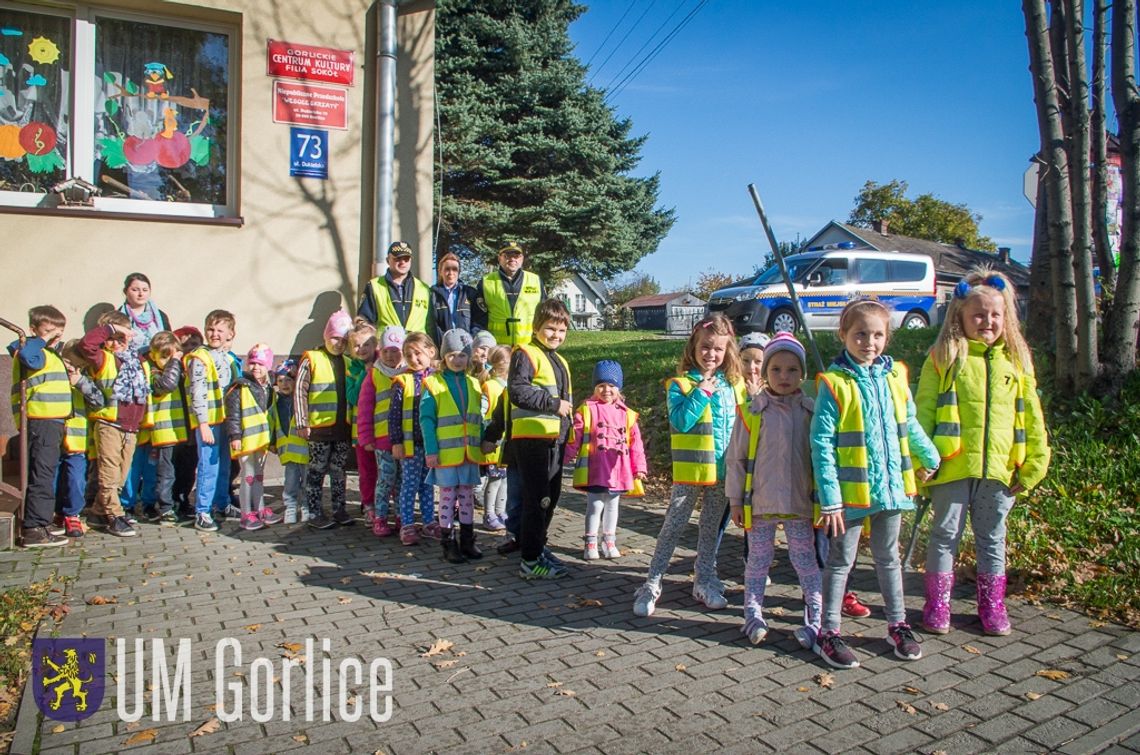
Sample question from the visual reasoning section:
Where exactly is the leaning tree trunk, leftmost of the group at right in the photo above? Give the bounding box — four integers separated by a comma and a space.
1021, 0, 1076, 395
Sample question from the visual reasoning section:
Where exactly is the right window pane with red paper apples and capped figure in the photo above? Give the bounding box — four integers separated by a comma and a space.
95, 18, 229, 204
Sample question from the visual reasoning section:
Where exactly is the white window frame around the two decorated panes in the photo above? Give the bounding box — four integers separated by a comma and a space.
0, 2, 242, 225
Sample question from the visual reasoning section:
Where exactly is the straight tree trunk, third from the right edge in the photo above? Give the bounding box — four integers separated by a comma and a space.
1065, 0, 1100, 391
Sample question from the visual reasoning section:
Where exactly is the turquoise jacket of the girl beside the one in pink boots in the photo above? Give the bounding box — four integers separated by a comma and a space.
812, 351, 939, 520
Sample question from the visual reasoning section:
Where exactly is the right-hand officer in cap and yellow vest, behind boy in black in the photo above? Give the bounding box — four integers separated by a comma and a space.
471, 242, 546, 347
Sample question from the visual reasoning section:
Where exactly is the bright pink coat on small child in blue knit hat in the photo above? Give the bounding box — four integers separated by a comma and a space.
565, 398, 648, 492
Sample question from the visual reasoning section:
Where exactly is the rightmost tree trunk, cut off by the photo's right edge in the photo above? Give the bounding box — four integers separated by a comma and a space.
1104, 0, 1140, 390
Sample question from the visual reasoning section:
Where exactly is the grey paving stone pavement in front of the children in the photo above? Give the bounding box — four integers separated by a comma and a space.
0, 487, 1140, 755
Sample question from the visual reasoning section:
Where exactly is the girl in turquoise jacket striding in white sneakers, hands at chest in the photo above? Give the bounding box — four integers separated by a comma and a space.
634, 315, 748, 616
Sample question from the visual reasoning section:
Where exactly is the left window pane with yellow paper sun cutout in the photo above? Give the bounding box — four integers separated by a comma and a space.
0, 8, 72, 193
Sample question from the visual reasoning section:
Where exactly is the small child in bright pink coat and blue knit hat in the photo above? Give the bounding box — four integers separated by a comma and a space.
567, 359, 646, 561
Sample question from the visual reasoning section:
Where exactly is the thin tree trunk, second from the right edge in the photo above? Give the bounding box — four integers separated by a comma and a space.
1090, 0, 1116, 297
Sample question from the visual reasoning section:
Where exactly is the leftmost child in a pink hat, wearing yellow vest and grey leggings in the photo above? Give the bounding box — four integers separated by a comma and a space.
226, 343, 282, 531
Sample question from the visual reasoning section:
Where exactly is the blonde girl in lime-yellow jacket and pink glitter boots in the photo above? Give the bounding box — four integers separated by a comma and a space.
917, 269, 1050, 635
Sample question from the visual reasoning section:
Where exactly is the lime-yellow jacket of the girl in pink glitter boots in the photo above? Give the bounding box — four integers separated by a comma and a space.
915, 341, 1051, 488
